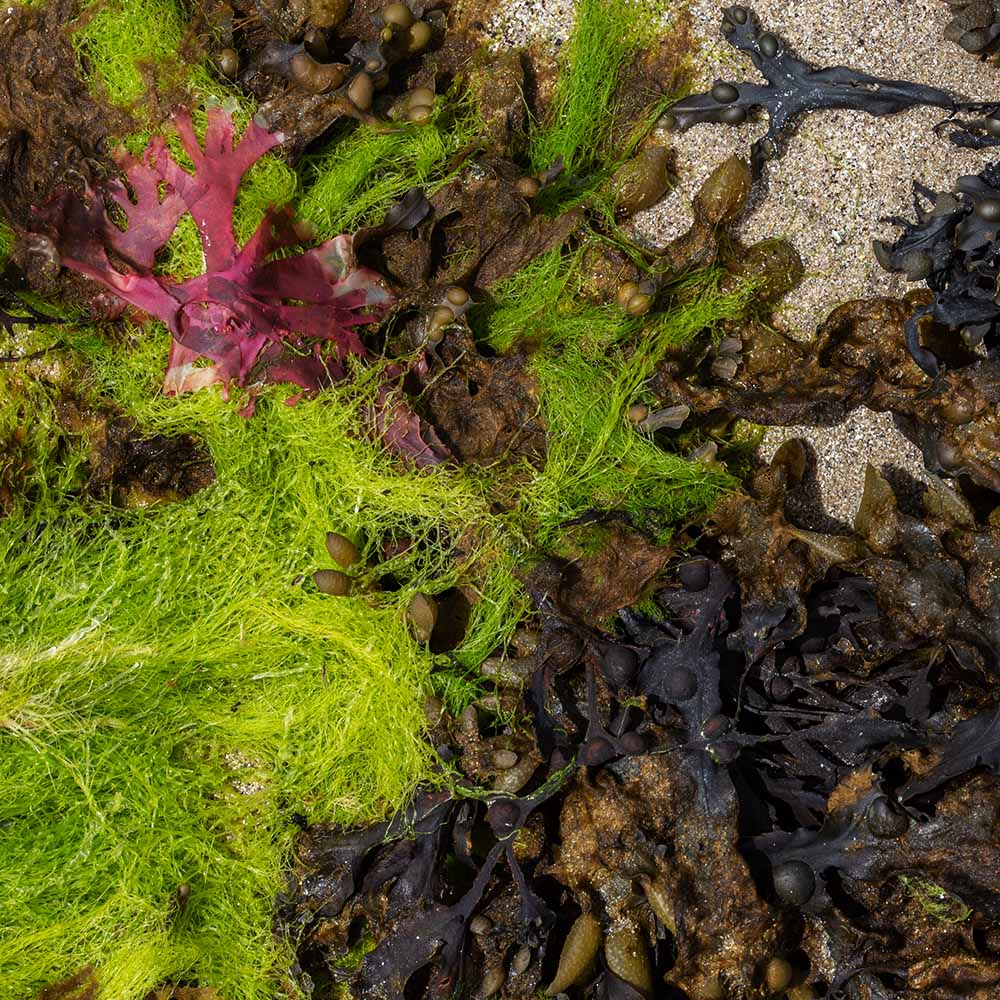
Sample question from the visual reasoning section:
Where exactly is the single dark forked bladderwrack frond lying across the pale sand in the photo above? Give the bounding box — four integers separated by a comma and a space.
668, 5, 959, 172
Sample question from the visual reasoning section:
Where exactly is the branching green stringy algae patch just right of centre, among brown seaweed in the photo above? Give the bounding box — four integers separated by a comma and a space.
473, 249, 752, 548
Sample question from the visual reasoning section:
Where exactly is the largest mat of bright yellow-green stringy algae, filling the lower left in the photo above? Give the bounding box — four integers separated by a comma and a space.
0, 330, 512, 1000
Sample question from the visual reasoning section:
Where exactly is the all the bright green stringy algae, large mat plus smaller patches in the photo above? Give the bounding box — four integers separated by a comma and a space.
0, 0, 749, 1000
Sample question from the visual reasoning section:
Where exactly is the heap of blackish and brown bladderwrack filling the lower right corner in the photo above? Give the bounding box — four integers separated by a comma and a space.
278, 450, 1000, 1000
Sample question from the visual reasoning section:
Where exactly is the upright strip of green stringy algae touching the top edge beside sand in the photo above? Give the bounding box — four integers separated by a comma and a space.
529, 0, 662, 175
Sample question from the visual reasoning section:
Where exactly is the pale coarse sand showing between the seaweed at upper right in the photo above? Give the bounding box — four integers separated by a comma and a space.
495, 0, 1000, 521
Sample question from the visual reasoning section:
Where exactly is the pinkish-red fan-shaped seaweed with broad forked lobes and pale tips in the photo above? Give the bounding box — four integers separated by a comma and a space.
32, 108, 391, 409
